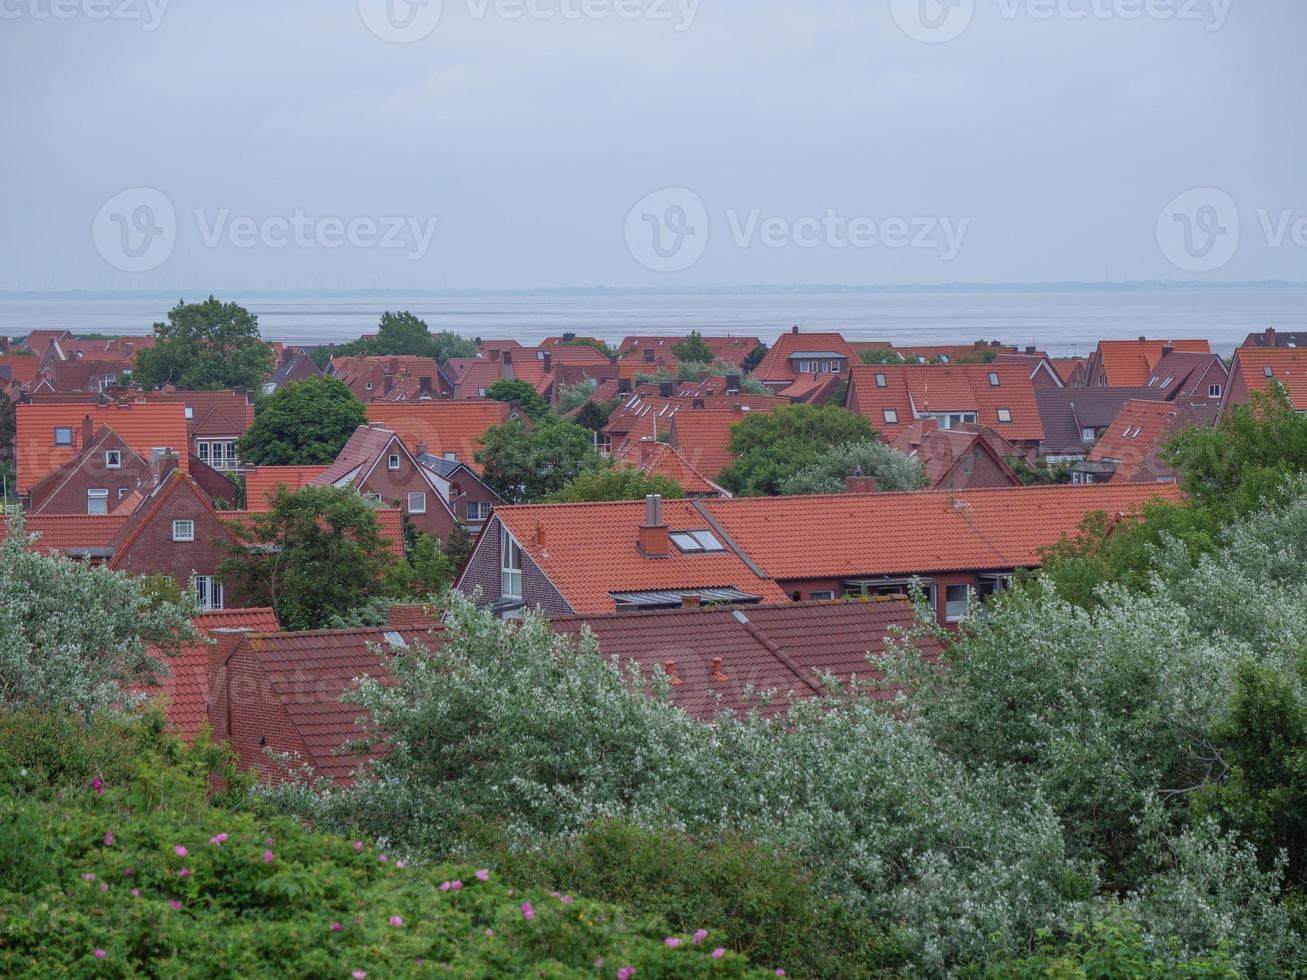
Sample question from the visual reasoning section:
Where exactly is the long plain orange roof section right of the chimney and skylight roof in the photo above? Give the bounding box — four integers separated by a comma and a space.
699, 483, 1182, 580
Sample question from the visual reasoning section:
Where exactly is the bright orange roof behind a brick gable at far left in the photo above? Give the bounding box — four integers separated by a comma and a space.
16, 402, 188, 494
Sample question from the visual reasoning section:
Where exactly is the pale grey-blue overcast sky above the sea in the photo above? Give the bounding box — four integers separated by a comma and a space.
0, 0, 1307, 290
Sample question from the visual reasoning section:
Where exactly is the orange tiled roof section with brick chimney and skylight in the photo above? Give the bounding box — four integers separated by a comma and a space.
480, 500, 786, 613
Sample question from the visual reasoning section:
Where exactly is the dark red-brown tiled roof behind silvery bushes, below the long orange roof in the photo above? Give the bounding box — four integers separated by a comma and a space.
549, 598, 940, 721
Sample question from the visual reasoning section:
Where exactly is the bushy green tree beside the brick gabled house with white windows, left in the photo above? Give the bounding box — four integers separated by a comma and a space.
221, 486, 396, 630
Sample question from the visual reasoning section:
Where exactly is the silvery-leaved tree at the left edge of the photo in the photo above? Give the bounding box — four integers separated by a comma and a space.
0, 519, 197, 716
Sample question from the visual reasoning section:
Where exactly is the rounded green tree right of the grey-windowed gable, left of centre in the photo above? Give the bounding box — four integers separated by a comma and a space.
477, 416, 604, 503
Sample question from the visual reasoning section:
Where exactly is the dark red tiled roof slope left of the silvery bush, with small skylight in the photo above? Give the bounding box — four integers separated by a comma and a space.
235, 626, 439, 783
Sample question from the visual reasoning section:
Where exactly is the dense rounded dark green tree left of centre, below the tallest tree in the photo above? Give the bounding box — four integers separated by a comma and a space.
237, 378, 367, 466
